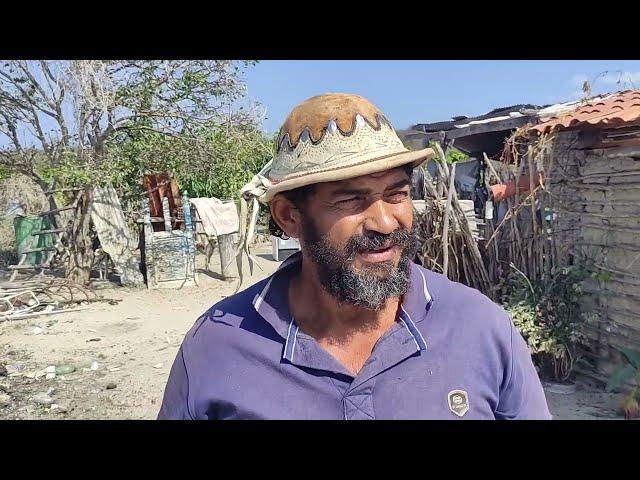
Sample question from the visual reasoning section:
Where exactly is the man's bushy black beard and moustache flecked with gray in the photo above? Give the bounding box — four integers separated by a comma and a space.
302, 218, 418, 311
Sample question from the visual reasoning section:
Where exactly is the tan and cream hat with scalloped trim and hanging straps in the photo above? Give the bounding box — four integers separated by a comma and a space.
237, 93, 434, 288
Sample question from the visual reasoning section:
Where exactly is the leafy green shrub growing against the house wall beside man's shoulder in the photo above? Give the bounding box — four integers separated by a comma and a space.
503, 264, 590, 381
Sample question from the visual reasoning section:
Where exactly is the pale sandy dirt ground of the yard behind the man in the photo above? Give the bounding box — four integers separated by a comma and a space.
0, 245, 632, 419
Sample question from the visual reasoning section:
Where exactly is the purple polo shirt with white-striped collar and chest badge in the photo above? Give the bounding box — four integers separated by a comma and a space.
158, 253, 551, 420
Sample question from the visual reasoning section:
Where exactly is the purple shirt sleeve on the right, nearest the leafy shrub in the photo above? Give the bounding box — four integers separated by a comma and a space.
495, 319, 552, 420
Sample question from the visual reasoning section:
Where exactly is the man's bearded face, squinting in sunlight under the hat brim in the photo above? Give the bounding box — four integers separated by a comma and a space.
300, 168, 417, 310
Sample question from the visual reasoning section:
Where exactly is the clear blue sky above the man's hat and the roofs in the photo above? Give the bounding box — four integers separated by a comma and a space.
245, 60, 640, 133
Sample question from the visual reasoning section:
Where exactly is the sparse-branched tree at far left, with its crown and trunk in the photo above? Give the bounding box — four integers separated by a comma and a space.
0, 60, 255, 283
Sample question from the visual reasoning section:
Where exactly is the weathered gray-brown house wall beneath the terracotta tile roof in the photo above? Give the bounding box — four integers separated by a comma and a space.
549, 129, 640, 378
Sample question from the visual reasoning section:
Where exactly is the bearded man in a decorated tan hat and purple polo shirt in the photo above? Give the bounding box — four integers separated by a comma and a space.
158, 94, 550, 419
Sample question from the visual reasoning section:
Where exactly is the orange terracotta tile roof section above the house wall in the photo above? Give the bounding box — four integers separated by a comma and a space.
532, 90, 640, 133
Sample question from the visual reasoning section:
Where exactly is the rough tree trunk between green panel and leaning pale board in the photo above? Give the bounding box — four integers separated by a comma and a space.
66, 186, 93, 285
